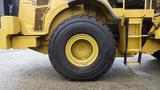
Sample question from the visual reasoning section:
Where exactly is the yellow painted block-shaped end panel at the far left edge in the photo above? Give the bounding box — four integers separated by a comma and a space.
0, 16, 20, 49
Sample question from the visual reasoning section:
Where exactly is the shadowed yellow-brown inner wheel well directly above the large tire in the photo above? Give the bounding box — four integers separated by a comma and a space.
46, 5, 118, 40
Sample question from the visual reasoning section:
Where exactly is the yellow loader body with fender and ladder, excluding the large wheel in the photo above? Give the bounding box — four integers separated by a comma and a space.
0, 0, 160, 56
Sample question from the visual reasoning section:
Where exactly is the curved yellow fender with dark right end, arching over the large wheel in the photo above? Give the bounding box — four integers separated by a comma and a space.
44, 0, 119, 37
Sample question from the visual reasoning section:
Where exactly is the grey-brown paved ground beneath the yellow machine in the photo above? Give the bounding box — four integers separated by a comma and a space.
0, 50, 160, 90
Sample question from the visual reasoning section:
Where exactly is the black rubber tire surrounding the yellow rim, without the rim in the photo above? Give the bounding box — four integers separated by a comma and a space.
49, 16, 116, 81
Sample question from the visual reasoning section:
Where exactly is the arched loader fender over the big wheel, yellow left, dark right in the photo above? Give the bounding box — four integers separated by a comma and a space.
44, 0, 120, 40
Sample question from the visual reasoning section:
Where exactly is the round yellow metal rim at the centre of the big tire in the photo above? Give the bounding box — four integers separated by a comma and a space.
65, 34, 99, 67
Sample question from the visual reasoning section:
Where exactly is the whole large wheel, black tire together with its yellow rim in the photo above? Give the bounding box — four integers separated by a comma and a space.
49, 16, 115, 80
